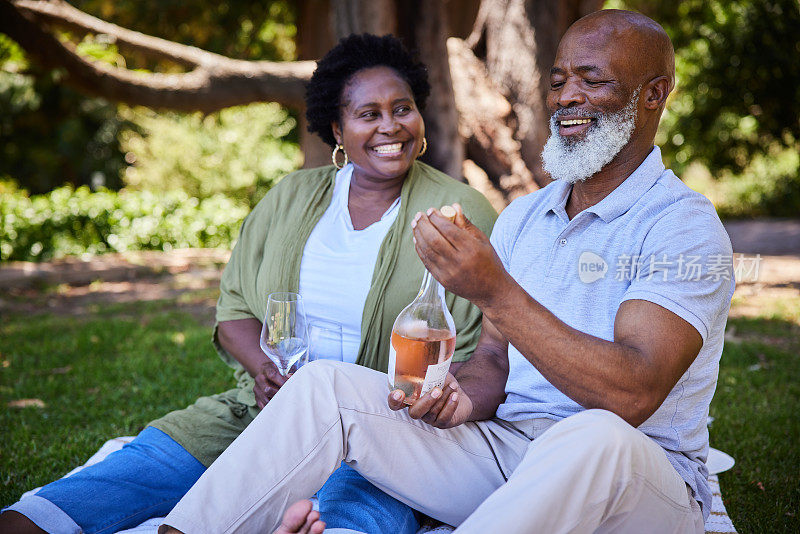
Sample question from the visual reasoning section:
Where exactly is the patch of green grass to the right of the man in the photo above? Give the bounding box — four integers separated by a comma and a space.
710, 303, 800, 532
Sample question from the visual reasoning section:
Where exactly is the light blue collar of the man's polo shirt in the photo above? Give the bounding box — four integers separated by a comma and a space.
548, 146, 666, 223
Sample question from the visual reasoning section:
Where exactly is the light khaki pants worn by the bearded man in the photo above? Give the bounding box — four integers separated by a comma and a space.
162, 361, 703, 534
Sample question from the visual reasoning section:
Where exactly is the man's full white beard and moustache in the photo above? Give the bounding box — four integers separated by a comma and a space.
542, 87, 641, 184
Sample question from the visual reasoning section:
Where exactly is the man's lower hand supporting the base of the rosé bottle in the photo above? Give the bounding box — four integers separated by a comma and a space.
389, 373, 472, 428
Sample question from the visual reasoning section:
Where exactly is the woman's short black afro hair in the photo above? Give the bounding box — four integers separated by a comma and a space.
306, 33, 431, 147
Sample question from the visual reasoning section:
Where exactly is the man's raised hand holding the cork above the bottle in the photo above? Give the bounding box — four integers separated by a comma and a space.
411, 204, 510, 307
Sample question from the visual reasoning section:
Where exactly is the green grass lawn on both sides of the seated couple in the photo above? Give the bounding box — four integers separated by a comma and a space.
0, 301, 800, 533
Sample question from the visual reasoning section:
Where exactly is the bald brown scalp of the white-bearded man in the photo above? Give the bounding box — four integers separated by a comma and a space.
562, 9, 675, 97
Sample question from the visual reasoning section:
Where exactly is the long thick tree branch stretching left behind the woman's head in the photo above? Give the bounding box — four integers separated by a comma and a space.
0, 0, 315, 113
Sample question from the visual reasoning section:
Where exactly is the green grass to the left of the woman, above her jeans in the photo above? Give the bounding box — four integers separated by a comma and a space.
0, 302, 235, 505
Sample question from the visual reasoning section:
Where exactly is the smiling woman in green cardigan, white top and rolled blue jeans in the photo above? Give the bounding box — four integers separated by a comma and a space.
0, 35, 496, 533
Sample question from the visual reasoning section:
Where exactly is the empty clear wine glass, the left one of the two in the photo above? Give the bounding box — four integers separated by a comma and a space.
260, 292, 308, 376
